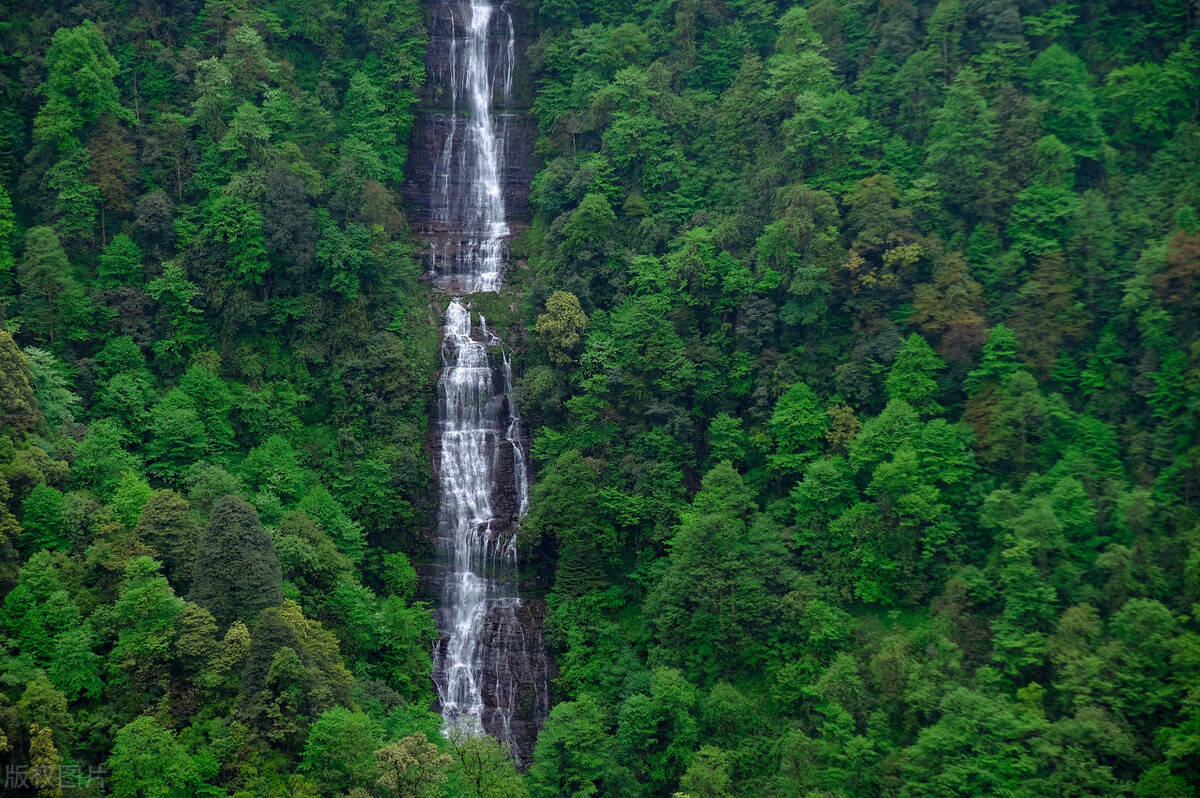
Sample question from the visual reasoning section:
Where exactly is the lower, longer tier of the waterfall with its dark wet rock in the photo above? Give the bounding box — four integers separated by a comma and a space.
427, 300, 550, 761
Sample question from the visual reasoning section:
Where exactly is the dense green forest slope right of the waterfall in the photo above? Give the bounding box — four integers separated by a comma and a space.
510, 0, 1200, 796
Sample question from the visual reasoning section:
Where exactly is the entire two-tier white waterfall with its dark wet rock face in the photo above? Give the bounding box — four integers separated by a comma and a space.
406, 0, 551, 764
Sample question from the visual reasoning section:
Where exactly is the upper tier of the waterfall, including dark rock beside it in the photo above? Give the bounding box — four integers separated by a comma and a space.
407, 0, 532, 294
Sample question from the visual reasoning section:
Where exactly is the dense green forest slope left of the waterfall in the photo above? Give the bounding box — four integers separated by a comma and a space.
0, 0, 432, 796
